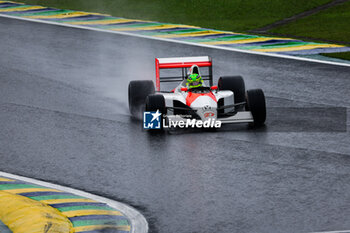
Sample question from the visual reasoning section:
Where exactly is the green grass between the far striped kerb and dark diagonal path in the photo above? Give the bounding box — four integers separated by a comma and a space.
17, 0, 330, 31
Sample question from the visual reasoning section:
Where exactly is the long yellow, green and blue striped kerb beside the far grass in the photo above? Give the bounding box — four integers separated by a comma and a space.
0, 1, 350, 56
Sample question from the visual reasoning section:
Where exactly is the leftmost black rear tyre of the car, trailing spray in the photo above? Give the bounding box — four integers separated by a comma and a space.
128, 80, 155, 119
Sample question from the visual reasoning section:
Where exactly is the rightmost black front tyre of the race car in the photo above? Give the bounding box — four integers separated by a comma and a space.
246, 89, 266, 127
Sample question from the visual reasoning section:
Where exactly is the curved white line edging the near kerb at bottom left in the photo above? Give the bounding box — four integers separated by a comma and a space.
0, 171, 148, 233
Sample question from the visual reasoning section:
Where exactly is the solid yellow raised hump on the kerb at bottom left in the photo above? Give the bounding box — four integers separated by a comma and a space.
0, 191, 74, 233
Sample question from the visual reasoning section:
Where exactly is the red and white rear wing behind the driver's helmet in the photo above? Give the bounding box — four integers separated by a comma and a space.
156, 56, 213, 91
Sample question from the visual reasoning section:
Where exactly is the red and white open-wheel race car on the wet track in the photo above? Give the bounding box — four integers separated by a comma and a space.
128, 56, 266, 128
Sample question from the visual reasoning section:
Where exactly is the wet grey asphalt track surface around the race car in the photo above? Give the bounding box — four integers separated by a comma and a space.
0, 18, 350, 233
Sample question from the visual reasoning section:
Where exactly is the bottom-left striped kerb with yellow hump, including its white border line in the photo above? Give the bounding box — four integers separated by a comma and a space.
0, 172, 148, 233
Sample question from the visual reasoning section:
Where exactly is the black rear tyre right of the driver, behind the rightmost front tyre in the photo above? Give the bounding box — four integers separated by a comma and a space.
218, 76, 245, 111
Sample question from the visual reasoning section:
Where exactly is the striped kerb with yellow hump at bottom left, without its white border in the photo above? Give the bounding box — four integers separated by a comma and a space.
0, 177, 131, 233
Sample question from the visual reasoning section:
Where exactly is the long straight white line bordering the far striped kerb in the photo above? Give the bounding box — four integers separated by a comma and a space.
0, 14, 350, 67
